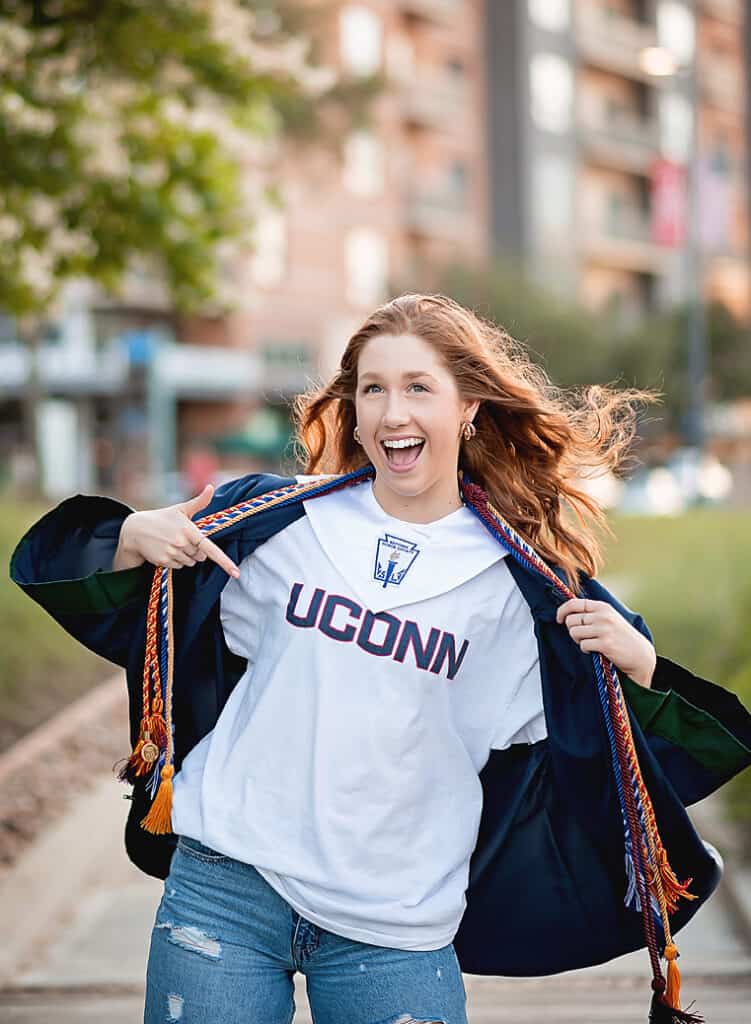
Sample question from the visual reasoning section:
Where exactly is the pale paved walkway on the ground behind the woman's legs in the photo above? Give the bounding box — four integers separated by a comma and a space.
0, 778, 751, 1024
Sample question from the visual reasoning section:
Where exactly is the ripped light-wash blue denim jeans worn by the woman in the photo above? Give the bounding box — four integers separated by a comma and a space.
143, 837, 467, 1024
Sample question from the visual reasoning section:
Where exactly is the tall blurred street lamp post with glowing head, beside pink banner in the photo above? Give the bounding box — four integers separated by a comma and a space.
640, 46, 707, 453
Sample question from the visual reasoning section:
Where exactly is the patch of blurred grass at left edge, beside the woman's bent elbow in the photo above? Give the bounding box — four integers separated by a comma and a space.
0, 499, 112, 750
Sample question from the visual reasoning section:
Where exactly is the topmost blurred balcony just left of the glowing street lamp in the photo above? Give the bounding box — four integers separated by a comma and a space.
576, 4, 657, 81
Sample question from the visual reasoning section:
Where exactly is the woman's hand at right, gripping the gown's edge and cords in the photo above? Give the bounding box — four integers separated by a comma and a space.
555, 597, 657, 688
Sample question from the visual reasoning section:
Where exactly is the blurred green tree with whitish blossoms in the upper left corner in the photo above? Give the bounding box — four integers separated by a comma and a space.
0, 0, 379, 491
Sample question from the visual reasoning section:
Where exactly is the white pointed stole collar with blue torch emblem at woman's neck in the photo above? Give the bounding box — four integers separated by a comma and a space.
302, 480, 507, 611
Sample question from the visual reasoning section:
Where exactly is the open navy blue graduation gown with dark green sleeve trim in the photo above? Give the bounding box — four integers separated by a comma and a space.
10, 474, 751, 976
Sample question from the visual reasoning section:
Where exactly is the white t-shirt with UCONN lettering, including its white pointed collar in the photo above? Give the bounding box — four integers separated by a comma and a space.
172, 480, 546, 949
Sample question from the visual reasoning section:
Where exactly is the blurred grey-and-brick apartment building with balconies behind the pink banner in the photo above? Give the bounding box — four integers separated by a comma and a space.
487, 0, 751, 326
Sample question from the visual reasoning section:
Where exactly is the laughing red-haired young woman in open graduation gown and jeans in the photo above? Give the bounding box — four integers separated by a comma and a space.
11, 295, 751, 1024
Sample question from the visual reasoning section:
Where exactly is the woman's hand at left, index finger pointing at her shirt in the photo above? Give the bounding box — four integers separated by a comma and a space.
113, 483, 240, 579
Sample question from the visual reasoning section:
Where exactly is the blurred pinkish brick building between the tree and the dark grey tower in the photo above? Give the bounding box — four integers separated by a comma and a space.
176, 0, 490, 444
